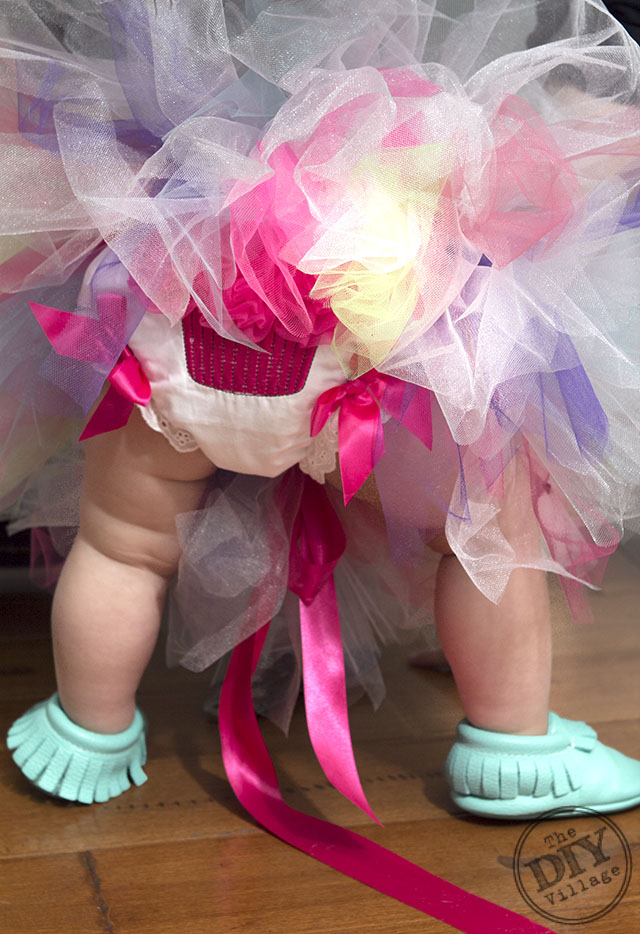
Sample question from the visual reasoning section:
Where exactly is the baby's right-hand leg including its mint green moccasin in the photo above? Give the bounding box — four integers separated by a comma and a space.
435, 462, 640, 819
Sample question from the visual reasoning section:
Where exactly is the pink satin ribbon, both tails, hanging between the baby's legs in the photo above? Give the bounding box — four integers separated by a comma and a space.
220, 478, 551, 934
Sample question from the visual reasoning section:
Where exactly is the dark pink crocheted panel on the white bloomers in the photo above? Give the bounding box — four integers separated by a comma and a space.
182, 309, 316, 396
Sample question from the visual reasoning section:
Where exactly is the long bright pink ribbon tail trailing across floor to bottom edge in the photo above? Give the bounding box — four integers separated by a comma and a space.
220, 624, 552, 934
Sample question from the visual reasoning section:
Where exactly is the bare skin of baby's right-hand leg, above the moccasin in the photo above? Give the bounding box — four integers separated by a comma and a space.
435, 461, 551, 735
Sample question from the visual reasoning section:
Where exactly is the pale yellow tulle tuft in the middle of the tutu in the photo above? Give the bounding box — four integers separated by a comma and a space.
312, 143, 450, 371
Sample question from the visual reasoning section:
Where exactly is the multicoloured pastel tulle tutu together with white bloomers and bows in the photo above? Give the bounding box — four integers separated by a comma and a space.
0, 0, 640, 716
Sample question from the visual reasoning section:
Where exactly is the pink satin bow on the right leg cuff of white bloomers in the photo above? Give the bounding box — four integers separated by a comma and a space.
311, 370, 432, 505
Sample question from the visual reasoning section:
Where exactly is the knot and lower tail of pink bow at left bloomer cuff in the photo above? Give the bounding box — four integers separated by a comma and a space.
80, 347, 151, 441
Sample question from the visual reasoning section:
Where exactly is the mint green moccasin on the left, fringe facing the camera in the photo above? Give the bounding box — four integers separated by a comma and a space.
7, 694, 147, 804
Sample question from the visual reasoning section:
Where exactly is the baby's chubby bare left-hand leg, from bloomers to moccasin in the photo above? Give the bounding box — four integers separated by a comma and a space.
53, 411, 214, 733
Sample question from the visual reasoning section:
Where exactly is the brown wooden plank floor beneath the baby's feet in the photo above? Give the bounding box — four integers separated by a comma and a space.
0, 554, 640, 934
